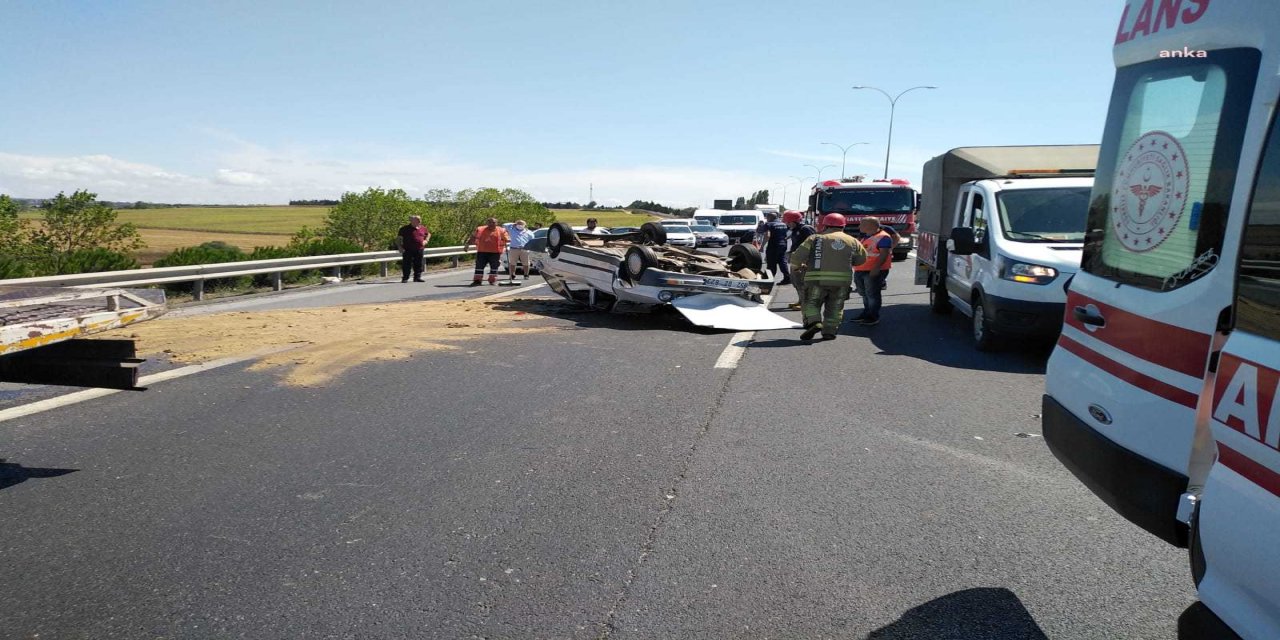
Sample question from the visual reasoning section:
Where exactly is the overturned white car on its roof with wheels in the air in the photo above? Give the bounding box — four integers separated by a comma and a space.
532, 223, 800, 330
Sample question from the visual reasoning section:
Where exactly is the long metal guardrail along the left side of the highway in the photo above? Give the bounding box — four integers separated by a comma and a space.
0, 244, 475, 300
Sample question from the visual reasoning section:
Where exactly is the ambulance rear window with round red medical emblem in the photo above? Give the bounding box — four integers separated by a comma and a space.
1082, 49, 1260, 291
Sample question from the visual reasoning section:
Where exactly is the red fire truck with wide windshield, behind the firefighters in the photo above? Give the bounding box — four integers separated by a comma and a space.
808, 178, 920, 260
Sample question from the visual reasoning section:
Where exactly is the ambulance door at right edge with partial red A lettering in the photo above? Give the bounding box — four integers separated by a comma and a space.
1197, 99, 1280, 637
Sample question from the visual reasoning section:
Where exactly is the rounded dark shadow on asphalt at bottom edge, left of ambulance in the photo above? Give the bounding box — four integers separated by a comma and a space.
867, 588, 1048, 640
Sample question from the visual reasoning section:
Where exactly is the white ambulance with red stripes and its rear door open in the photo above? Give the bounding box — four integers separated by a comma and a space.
1042, 0, 1280, 639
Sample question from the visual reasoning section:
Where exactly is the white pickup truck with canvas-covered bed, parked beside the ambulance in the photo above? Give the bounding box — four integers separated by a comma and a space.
915, 145, 1098, 351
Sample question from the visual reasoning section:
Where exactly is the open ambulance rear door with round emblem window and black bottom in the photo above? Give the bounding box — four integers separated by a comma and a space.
1044, 49, 1260, 544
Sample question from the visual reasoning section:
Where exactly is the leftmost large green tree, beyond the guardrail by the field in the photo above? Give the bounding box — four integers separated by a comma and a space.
27, 189, 146, 273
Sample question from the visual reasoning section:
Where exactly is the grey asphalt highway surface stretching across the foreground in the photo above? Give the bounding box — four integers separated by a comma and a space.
0, 264, 1194, 639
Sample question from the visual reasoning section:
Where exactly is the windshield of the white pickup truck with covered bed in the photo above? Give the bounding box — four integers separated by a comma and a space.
996, 187, 1091, 242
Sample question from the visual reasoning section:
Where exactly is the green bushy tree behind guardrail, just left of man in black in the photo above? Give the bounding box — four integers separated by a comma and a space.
315, 187, 425, 251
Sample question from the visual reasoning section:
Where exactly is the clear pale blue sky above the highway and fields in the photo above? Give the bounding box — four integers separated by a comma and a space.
0, 0, 1121, 206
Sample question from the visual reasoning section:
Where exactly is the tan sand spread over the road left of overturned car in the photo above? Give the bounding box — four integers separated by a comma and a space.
102, 301, 554, 387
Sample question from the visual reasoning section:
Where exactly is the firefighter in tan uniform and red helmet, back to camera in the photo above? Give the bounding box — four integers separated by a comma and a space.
791, 214, 867, 340
